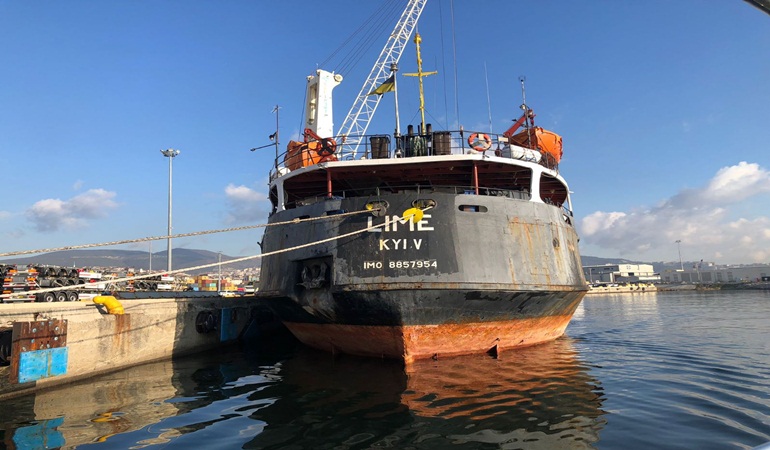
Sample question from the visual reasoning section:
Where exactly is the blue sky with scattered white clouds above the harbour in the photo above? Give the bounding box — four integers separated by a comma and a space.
0, 0, 770, 263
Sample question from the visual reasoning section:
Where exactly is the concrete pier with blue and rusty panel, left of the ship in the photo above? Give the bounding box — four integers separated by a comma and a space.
0, 296, 277, 398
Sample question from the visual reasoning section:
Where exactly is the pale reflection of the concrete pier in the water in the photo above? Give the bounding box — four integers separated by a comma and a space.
0, 342, 278, 449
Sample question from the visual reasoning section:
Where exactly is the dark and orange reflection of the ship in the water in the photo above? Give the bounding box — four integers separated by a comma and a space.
246, 338, 604, 448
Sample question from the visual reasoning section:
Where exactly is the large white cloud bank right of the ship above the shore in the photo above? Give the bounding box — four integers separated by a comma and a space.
580, 162, 770, 263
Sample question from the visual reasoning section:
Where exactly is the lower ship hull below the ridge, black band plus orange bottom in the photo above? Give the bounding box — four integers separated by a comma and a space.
260, 288, 583, 363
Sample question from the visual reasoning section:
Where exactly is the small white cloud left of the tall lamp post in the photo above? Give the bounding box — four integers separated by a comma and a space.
25, 189, 118, 231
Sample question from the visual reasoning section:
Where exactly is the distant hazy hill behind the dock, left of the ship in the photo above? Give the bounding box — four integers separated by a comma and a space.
0, 248, 260, 274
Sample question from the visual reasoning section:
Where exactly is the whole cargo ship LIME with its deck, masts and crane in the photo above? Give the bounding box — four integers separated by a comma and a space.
259, 0, 588, 364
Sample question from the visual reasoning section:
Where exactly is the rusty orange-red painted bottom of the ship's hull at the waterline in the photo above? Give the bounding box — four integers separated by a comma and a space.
285, 313, 572, 364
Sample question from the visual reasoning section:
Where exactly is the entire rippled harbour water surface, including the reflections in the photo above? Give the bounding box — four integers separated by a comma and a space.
0, 291, 770, 449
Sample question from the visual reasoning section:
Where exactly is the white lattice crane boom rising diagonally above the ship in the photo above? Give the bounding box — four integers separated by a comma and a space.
337, 0, 427, 153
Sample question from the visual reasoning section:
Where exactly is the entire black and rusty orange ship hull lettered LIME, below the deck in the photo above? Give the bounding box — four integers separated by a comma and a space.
255, 188, 587, 363
